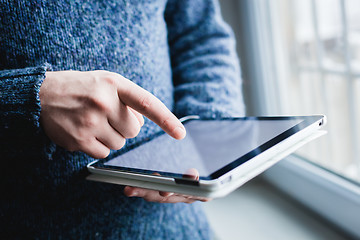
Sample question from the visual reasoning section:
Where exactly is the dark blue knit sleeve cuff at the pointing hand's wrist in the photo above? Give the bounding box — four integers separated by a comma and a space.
0, 64, 54, 159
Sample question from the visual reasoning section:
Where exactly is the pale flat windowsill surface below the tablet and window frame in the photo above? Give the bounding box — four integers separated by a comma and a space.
204, 176, 347, 240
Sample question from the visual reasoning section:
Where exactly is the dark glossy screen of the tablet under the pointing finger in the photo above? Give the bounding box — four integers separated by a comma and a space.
95, 117, 321, 179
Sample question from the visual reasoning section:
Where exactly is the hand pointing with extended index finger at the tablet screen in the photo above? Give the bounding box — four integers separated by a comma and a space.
39, 71, 186, 158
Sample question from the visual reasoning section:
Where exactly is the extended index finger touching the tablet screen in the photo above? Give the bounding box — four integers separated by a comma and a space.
118, 75, 186, 139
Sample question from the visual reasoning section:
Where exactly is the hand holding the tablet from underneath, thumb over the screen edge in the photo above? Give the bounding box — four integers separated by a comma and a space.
124, 168, 211, 203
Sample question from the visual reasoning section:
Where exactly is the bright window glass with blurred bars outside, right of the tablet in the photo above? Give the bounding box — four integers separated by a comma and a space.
275, 0, 360, 182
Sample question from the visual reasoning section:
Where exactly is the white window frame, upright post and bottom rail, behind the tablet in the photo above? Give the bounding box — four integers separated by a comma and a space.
239, 0, 360, 239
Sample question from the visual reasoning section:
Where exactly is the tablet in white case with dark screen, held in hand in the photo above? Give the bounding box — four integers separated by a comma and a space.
87, 116, 325, 198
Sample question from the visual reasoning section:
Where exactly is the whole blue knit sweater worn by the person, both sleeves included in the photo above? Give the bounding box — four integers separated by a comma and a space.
0, 0, 244, 239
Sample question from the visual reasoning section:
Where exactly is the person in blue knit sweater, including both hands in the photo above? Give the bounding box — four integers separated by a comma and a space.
0, 0, 244, 239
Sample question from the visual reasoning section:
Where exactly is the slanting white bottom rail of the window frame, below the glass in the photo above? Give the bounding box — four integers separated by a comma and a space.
264, 155, 360, 239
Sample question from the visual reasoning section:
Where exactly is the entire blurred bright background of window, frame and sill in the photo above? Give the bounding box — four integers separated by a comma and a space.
205, 0, 360, 239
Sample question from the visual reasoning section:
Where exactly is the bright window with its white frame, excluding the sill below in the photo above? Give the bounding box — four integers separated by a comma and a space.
228, 0, 360, 238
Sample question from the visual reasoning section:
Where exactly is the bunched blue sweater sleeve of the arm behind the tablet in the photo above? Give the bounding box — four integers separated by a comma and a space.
165, 0, 245, 118
